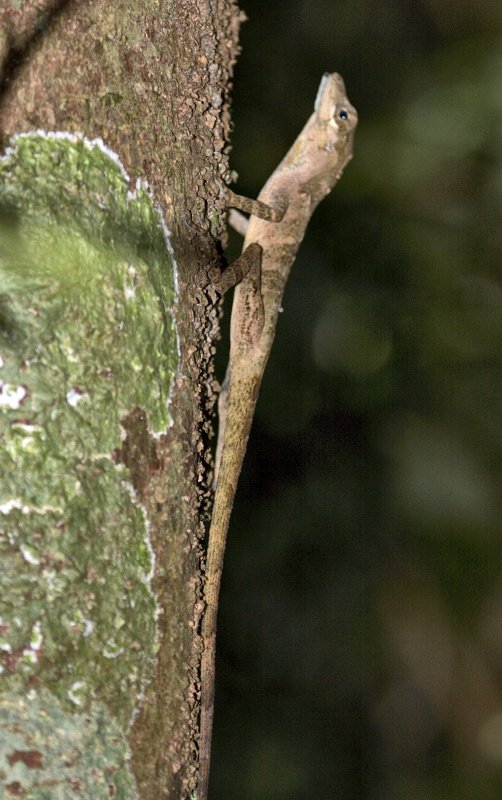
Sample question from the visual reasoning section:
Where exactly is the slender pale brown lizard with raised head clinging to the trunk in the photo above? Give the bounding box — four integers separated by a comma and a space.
197, 73, 357, 800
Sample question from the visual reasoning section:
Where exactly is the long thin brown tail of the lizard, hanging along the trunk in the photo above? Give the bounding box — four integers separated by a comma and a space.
198, 374, 258, 800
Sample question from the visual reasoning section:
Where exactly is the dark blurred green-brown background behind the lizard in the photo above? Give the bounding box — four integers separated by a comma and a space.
212, 0, 502, 800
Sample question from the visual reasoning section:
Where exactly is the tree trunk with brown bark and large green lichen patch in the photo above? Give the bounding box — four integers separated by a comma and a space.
0, 0, 239, 800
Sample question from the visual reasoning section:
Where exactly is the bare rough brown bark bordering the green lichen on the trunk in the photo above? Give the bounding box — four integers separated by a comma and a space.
0, 0, 240, 800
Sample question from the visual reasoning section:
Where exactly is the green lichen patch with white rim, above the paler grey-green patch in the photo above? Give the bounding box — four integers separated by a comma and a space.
0, 134, 178, 798
